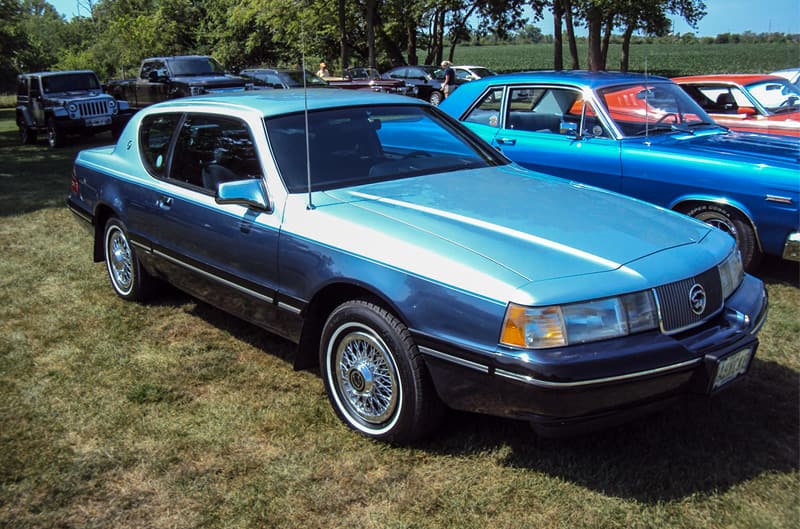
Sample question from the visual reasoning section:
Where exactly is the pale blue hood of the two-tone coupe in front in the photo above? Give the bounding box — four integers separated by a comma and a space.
318, 165, 711, 284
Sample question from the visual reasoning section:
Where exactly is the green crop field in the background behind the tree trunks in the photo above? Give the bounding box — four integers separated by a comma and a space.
454, 43, 800, 77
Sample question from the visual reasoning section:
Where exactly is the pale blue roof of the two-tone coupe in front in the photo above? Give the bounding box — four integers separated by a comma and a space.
148, 88, 427, 117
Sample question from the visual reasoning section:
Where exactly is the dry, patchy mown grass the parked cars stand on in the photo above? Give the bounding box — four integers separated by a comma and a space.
0, 104, 800, 529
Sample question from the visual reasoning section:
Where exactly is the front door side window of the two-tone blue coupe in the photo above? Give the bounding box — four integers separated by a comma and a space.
169, 115, 262, 192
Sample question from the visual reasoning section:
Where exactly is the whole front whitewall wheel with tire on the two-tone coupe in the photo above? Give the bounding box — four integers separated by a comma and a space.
320, 300, 443, 443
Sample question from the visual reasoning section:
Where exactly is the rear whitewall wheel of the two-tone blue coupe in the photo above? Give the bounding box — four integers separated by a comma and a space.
103, 217, 153, 301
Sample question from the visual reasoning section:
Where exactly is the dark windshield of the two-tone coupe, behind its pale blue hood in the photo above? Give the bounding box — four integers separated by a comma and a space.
264, 105, 508, 193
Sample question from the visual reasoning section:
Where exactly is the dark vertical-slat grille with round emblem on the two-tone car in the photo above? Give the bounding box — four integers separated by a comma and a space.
655, 267, 723, 334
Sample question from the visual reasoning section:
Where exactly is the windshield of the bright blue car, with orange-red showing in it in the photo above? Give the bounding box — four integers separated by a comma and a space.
598, 82, 714, 136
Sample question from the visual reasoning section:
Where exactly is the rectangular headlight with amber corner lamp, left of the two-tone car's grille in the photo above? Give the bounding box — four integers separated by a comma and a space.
500, 290, 658, 349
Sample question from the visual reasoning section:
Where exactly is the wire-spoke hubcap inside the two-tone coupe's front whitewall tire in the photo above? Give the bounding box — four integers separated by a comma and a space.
332, 330, 399, 424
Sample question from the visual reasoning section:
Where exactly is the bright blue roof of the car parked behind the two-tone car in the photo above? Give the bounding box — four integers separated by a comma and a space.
460, 70, 671, 88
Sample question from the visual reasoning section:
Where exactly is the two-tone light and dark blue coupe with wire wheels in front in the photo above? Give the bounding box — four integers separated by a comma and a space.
68, 90, 767, 442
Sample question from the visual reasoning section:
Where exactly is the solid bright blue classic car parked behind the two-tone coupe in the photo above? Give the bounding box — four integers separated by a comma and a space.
441, 72, 800, 270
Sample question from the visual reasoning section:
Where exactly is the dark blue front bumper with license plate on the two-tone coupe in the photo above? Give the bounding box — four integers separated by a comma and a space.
417, 276, 767, 434
